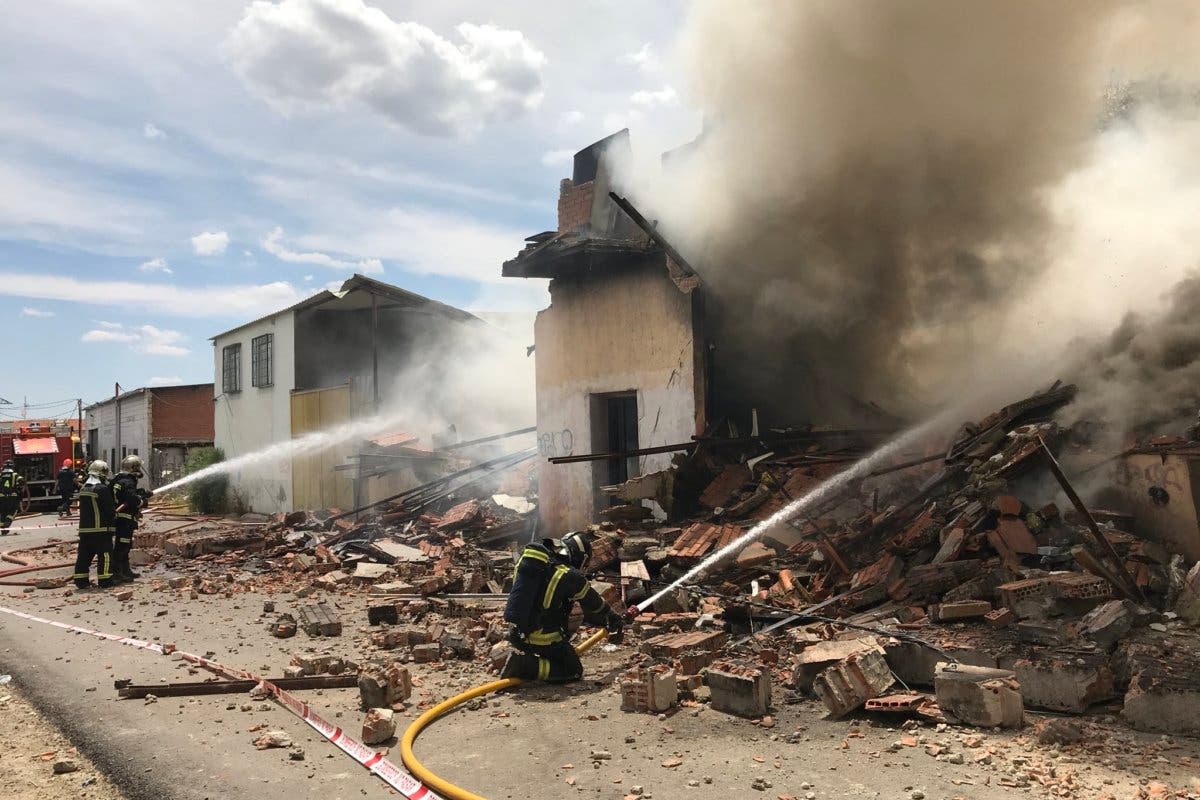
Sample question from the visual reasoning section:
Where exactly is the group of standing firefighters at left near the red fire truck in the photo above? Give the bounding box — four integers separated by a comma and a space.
0, 456, 150, 589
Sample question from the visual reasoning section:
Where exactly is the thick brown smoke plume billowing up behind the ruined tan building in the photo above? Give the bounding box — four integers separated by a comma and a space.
630, 0, 1200, 429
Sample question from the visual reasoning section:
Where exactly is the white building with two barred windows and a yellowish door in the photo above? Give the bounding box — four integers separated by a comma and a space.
212, 275, 482, 513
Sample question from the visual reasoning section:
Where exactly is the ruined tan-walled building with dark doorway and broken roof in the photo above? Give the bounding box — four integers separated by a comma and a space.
502, 131, 896, 531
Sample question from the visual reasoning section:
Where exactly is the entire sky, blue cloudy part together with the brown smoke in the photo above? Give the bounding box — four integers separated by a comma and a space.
7, 0, 1200, 438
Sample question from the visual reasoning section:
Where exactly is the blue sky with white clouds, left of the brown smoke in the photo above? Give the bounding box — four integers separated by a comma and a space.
0, 0, 698, 416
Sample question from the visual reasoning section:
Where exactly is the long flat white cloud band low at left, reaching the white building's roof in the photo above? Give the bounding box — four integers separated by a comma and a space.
0, 272, 307, 316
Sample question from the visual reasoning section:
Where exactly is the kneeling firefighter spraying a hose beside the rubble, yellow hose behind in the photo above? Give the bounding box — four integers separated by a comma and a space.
500, 533, 625, 681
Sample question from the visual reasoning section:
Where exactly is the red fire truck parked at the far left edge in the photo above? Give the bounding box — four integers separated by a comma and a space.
0, 420, 83, 513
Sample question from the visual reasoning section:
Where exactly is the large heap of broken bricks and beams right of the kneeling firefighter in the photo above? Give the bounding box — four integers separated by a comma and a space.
568, 385, 1200, 732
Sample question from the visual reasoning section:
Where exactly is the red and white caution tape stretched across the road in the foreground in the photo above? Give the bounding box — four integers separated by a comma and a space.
0, 606, 442, 800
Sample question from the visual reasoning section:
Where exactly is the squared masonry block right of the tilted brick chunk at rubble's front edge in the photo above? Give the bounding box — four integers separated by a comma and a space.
934, 661, 1025, 728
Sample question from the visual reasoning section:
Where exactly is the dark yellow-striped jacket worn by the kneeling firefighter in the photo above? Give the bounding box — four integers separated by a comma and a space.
504, 545, 611, 646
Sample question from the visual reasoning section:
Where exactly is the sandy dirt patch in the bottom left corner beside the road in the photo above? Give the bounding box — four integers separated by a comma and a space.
0, 681, 125, 800
